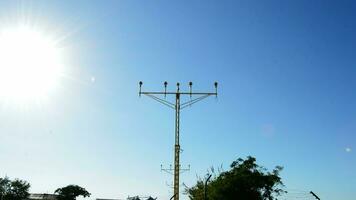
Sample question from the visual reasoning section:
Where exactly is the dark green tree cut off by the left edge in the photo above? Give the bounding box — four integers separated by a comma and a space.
0, 177, 30, 200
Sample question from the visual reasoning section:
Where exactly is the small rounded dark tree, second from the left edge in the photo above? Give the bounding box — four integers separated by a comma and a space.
54, 185, 90, 200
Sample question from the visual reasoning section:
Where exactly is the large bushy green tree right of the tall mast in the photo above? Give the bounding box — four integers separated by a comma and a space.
186, 156, 284, 200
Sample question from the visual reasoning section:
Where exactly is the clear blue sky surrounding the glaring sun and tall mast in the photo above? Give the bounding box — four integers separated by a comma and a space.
0, 0, 356, 200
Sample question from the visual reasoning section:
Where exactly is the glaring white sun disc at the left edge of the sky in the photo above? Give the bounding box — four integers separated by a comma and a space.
0, 27, 61, 101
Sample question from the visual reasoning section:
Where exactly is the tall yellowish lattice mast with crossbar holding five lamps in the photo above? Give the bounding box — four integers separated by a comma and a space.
139, 81, 218, 200
